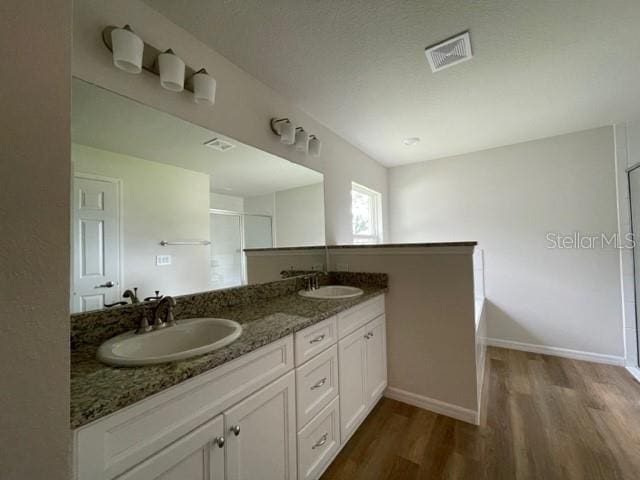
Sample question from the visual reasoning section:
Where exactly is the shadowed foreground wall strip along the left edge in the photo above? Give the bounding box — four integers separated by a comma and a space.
0, 0, 71, 480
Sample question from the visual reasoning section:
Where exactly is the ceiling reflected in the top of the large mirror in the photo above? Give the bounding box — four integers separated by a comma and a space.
71, 79, 323, 197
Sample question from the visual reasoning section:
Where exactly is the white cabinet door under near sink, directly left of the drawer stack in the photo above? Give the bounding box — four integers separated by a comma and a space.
224, 372, 296, 480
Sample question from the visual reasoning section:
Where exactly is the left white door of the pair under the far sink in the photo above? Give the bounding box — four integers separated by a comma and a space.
338, 325, 367, 443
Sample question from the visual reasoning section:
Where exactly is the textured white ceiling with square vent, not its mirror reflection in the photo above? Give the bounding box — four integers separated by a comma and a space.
145, 0, 640, 166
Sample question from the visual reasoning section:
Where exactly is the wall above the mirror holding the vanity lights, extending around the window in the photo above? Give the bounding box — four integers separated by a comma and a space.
73, 0, 387, 244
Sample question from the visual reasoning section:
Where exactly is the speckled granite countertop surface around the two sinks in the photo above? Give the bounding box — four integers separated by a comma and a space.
71, 286, 386, 429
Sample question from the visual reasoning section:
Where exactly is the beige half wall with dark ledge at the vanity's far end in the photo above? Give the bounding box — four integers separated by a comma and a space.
329, 247, 478, 422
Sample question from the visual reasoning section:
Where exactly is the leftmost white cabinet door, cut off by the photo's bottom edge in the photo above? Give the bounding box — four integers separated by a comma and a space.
117, 415, 224, 480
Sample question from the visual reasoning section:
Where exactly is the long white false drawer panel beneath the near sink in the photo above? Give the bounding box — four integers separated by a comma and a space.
74, 335, 293, 480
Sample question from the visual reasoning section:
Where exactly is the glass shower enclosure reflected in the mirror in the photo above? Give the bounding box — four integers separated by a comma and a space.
209, 210, 273, 290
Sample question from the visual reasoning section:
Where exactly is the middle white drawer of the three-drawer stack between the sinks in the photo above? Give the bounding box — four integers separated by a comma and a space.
296, 345, 339, 429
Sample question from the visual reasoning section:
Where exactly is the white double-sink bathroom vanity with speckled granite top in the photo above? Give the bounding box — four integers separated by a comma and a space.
72, 280, 387, 480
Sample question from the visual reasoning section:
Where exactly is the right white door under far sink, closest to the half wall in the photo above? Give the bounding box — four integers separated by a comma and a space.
364, 315, 387, 407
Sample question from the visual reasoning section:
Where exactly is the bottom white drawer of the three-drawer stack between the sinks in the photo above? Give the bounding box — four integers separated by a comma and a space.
298, 397, 340, 480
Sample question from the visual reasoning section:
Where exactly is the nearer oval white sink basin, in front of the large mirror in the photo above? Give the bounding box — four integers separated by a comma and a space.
98, 318, 242, 367
